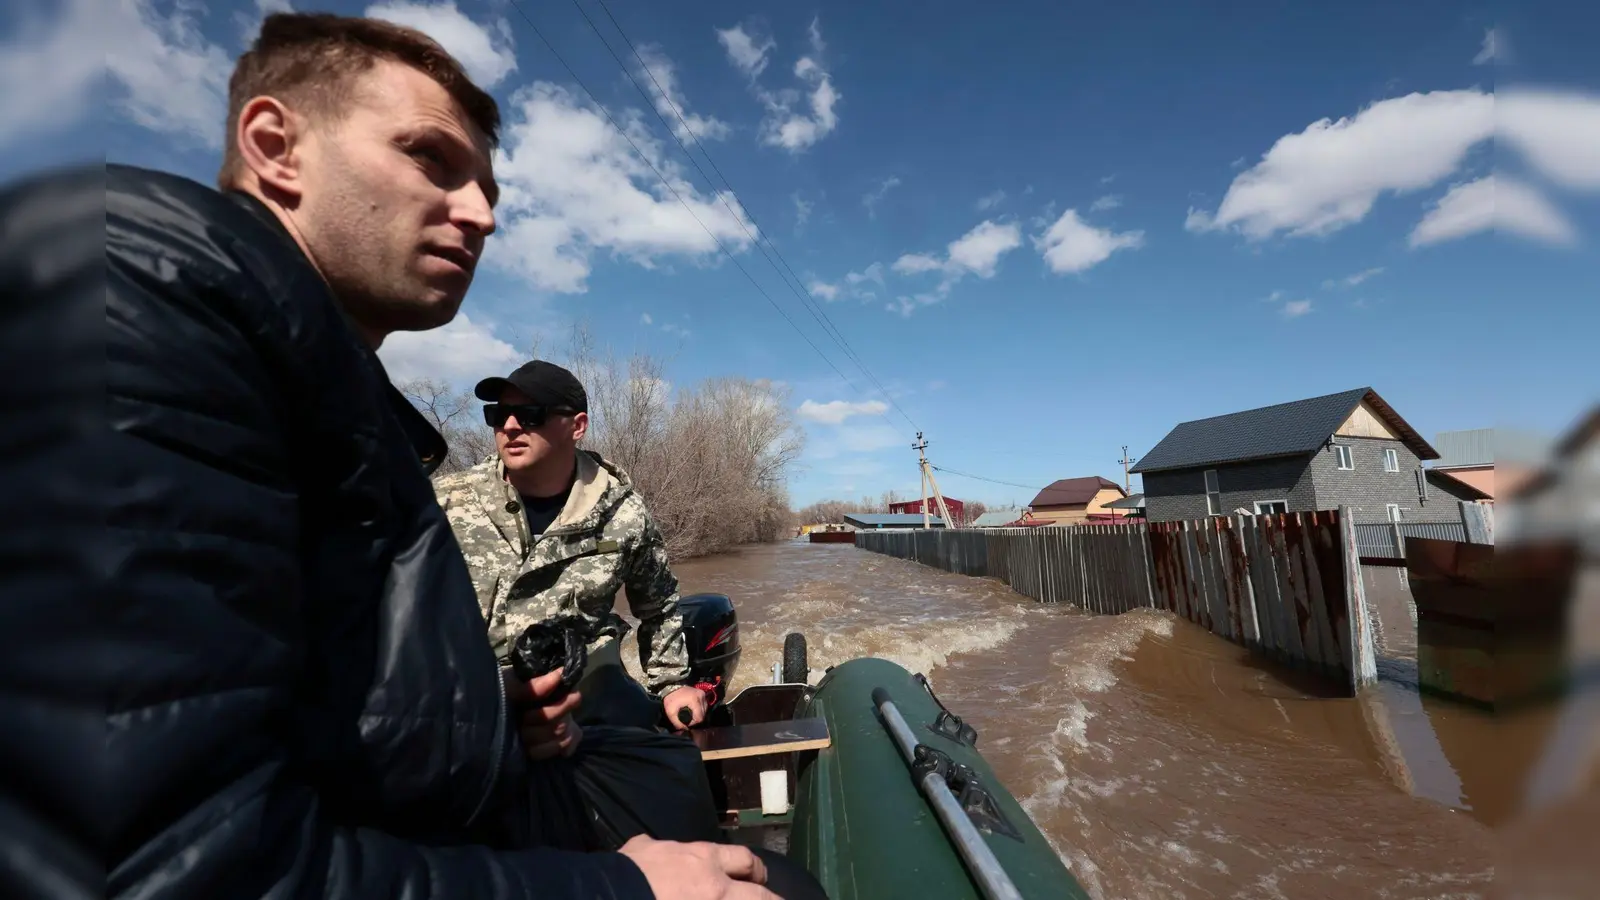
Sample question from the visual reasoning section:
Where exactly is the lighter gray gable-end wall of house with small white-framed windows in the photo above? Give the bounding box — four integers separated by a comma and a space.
1310, 436, 1461, 524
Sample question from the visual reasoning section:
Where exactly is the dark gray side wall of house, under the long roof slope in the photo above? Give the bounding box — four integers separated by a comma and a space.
1142, 456, 1318, 522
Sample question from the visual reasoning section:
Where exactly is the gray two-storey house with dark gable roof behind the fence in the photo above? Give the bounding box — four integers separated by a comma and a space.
1131, 381, 1486, 522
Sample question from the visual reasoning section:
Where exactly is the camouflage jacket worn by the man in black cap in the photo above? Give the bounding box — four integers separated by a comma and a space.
434, 450, 690, 697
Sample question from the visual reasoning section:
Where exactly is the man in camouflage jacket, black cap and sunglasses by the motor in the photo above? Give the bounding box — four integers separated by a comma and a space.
434, 360, 706, 743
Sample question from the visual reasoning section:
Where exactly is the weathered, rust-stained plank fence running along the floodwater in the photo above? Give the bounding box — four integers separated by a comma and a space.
856, 509, 1378, 693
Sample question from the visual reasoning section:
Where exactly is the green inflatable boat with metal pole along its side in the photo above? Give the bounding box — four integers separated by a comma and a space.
694, 634, 1088, 900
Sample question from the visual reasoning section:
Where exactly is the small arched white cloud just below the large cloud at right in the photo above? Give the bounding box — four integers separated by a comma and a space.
1411, 175, 1578, 247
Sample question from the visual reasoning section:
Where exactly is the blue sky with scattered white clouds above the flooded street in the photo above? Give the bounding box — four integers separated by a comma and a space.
9, 0, 1600, 504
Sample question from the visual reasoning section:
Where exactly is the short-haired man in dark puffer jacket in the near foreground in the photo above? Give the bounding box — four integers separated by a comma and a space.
0, 14, 773, 898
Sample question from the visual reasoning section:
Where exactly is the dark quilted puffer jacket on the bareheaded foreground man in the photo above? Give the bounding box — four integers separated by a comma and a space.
12, 165, 651, 900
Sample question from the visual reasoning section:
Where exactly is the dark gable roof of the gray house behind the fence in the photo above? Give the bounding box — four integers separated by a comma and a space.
1131, 388, 1438, 472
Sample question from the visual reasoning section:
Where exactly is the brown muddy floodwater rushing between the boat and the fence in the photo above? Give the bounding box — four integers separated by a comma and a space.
626, 543, 1493, 900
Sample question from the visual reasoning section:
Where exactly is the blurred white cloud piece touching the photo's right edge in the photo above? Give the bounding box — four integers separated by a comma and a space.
1494, 88, 1600, 191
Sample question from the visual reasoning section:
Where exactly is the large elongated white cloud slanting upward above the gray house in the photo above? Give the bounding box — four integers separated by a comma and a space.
1184, 90, 1494, 240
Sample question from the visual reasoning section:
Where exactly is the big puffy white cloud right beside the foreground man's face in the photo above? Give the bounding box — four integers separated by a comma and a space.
485, 82, 755, 291
